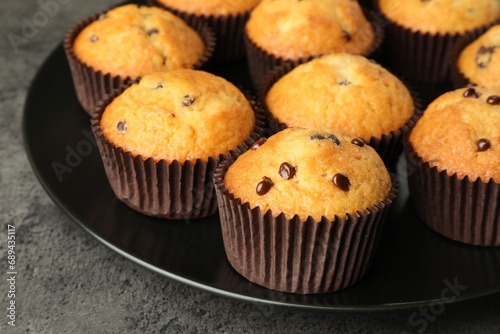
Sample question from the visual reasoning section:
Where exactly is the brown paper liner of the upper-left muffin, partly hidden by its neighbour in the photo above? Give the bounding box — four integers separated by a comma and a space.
63, 6, 215, 115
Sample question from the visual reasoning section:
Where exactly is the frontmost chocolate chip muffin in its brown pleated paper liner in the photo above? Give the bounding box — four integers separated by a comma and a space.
214, 128, 396, 294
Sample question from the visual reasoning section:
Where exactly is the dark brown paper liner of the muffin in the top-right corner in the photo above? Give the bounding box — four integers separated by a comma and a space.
373, 0, 498, 84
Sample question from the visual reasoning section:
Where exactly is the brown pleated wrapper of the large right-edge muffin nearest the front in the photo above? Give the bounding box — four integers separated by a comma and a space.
405, 139, 500, 246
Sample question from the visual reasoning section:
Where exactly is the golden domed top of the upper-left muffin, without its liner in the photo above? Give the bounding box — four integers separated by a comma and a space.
73, 5, 205, 78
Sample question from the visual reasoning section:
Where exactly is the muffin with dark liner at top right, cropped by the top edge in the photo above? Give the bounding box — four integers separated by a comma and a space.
376, 0, 500, 83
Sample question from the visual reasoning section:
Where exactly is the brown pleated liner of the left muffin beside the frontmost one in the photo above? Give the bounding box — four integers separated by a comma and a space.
91, 87, 265, 219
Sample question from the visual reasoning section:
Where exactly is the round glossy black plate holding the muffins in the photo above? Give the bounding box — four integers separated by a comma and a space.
23, 46, 500, 311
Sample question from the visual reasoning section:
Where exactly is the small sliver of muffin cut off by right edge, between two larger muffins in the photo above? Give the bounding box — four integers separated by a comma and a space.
453, 25, 500, 87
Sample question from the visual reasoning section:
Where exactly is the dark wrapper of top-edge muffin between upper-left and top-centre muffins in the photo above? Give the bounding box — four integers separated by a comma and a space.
147, 0, 250, 62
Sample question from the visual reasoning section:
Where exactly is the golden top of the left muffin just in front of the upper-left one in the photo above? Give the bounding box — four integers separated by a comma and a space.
100, 69, 255, 162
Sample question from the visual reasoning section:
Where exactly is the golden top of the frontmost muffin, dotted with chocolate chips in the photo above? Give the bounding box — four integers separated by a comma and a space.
223, 128, 392, 221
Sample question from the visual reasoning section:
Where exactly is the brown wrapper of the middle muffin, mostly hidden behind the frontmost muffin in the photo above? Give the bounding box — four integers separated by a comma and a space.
257, 64, 423, 171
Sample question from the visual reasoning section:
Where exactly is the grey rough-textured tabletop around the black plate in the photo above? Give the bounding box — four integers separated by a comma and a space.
0, 0, 500, 334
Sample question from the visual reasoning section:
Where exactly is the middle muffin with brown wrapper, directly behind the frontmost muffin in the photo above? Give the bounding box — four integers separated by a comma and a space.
260, 53, 421, 168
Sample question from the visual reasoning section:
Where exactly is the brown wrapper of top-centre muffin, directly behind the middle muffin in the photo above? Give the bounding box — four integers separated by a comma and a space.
244, 8, 385, 89
